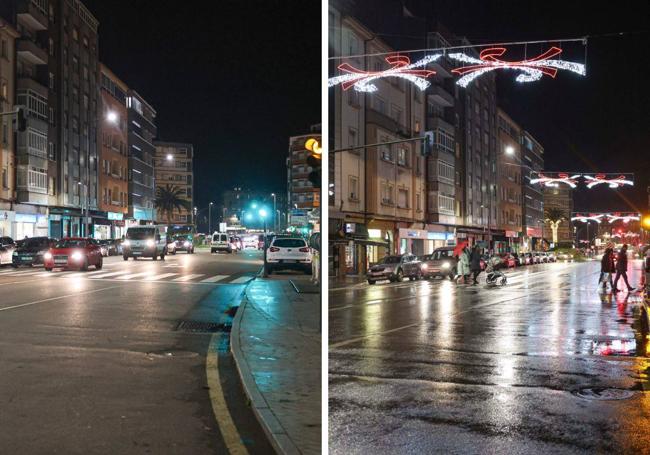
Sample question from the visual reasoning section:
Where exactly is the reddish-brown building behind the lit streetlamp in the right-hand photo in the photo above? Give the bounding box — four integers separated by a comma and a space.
494, 109, 523, 252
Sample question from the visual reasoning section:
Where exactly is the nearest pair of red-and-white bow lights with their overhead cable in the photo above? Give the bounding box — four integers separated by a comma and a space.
327, 38, 587, 92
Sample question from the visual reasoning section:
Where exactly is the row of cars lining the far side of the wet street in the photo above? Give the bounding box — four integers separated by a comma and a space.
366, 246, 557, 284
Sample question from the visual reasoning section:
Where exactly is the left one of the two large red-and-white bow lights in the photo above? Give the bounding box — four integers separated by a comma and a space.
327, 54, 442, 92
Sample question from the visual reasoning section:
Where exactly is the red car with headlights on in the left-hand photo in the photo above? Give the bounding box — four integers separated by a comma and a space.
43, 237, 104, 272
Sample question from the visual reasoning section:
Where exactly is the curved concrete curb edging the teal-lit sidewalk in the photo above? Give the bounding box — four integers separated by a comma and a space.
230, 286, 300, 455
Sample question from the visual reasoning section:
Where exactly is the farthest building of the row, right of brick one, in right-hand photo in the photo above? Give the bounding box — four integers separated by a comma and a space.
521, 130, 544, 251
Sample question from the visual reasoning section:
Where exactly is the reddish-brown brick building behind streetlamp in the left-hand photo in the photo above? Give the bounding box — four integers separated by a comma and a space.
95, 64, 129, 242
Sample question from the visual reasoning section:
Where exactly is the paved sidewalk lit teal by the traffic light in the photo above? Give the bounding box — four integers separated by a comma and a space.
230, 276, 321, 454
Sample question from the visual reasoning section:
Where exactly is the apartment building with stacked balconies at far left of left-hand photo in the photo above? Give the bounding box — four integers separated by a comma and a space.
0, 0, 51, 238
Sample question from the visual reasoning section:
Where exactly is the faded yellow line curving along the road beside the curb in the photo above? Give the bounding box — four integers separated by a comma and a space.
205, 334, 248, 455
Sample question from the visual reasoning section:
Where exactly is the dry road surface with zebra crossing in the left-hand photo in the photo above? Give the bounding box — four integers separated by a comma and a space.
0, 250, 272, 454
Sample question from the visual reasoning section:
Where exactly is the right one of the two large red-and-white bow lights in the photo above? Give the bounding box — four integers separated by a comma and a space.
449, 46, 587, 87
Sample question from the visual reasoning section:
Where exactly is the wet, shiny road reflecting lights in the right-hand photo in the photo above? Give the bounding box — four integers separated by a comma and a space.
329, 261, 650, 453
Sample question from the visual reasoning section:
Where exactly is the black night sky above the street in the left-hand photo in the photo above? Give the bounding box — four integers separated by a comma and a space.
83, 0, 321, 214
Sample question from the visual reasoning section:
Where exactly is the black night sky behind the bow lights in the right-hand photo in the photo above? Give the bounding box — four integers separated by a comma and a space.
359, 0, 650, 211
